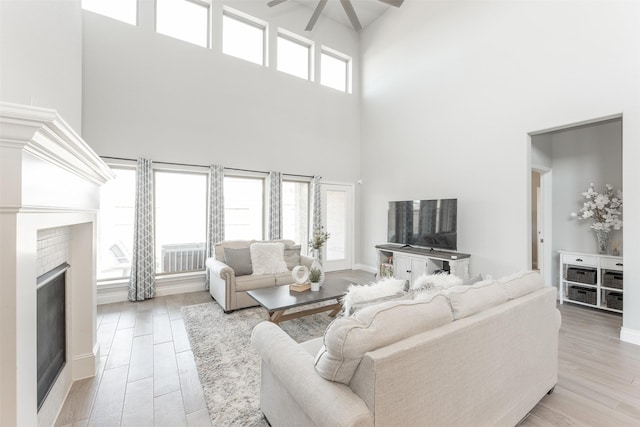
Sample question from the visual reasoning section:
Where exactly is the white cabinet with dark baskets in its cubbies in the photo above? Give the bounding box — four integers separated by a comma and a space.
560, 251, 623, 313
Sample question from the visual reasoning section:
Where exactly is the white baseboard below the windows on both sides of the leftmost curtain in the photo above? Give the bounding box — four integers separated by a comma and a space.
97, 273, 205, 305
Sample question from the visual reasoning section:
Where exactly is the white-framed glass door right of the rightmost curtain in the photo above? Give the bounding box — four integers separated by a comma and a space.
322, 183, 354, 271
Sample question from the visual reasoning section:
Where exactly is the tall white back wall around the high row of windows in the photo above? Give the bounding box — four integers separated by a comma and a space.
83, 0, 360, 182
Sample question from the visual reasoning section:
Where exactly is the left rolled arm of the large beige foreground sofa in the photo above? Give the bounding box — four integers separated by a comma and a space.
251, 322, 373, 426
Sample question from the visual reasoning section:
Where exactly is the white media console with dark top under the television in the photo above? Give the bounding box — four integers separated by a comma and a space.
376, 244, 471, 283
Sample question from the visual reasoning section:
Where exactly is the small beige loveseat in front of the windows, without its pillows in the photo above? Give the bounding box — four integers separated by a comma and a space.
206, 240, 313, 312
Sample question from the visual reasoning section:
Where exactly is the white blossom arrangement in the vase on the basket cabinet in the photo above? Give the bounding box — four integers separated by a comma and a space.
571, 183, 622, 233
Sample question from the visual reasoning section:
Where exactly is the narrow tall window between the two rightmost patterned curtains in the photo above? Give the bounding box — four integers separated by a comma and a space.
282, 181, 309, 247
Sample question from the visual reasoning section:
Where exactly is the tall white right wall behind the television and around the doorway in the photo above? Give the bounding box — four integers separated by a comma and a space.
360, 1, 640, 343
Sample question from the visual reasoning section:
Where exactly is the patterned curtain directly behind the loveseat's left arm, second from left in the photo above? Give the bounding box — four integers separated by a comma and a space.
204, 165, 224, 289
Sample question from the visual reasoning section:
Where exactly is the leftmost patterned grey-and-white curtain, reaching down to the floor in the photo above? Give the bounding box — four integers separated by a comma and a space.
129, 159, 156, 301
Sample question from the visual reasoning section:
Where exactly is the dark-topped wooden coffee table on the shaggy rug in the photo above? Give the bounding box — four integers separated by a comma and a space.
247, 278, 351, 324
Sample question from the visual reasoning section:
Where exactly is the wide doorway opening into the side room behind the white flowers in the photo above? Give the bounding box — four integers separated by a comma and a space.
527, 115, 622, 286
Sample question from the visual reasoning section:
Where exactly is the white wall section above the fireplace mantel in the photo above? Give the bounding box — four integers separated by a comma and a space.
0, 0, 82, 133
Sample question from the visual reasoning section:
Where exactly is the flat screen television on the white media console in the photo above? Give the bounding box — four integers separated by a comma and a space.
387, 199, 458, 251
